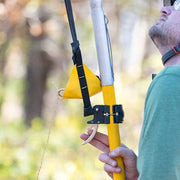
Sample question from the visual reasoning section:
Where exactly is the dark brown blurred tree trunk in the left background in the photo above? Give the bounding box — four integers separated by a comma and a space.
26, 37, 52, 125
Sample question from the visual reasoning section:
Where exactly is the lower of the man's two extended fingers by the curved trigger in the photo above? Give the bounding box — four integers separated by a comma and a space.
80, 134, 109, 153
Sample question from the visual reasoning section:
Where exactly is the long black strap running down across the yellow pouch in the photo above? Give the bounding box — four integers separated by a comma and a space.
64, 0, 93, 116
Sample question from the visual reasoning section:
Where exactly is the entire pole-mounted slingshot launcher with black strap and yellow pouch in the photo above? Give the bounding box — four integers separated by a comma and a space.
62, 0, 125, 180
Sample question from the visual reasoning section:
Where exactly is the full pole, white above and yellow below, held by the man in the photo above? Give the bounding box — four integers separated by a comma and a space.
90, 0, 125, 180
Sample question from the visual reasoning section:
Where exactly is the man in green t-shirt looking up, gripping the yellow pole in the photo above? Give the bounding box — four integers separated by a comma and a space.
81, 0, 180, 180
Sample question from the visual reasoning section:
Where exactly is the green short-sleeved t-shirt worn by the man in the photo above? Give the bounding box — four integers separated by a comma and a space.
137, 65, 180, 180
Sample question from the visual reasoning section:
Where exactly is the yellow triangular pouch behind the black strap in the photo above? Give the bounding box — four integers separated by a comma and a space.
62, 64, 101, 99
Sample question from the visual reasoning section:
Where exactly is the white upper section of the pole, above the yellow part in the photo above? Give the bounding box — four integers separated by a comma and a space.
90, 0, 114, 86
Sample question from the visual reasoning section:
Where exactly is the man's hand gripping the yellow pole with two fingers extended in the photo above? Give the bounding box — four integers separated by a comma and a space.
80, 130, 139, 180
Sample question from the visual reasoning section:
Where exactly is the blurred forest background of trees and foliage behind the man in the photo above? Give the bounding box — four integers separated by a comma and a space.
0, 0, 163, 180
